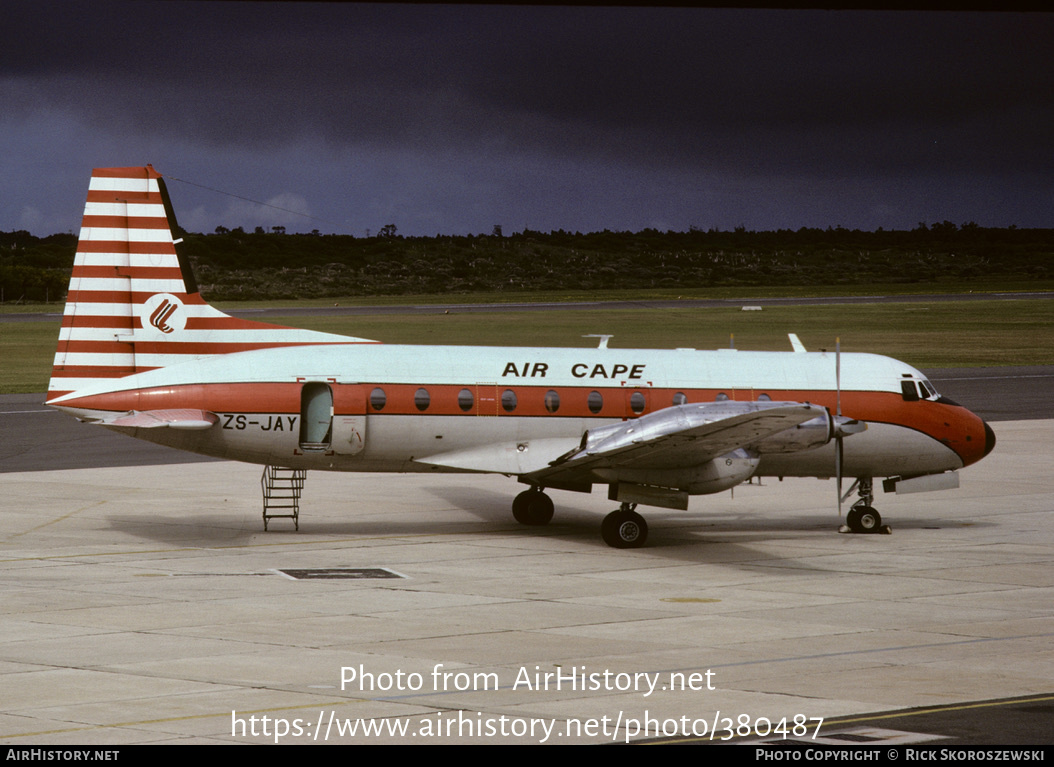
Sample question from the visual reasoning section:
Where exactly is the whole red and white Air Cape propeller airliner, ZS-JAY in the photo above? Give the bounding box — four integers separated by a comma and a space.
47, 165, 995, 548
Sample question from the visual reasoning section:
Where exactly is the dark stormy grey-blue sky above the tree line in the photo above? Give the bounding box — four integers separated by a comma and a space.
0, 2, 1054, 235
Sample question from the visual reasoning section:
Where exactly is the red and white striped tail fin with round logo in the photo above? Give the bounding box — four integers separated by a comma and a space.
47, 165, 370, 401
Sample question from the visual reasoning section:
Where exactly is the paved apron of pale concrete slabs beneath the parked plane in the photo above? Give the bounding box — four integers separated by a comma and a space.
0, 383, 1054, 745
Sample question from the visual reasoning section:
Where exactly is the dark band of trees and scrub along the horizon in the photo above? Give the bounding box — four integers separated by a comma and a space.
0, 221, 1054, 302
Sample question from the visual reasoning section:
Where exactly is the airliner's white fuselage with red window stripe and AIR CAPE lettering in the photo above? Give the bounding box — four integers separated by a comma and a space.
47, 345, 985, 484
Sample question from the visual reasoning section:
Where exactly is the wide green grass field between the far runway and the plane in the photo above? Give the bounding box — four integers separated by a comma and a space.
0, 296, 1054, 393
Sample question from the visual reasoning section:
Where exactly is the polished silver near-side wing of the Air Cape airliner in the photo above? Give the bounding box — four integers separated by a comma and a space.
522, 401, 833, 487
